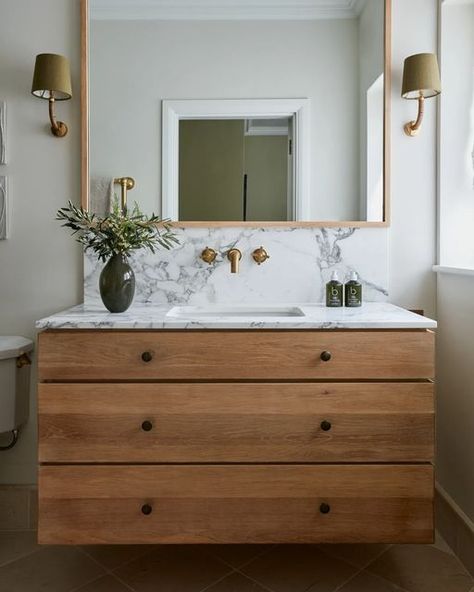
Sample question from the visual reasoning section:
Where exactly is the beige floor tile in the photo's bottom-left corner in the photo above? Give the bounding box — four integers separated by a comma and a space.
0, 547, 104, 592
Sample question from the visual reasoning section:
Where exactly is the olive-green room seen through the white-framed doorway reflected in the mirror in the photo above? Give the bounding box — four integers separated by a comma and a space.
179, 118, 293, 222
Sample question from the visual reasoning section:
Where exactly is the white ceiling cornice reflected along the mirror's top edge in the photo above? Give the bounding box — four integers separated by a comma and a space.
90, 0, 368, 20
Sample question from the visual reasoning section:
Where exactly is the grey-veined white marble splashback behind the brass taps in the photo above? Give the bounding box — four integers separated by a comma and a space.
84, 227, 388, 305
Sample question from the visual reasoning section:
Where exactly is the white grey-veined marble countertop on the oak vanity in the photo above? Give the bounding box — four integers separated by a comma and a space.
36, 302, 437, 330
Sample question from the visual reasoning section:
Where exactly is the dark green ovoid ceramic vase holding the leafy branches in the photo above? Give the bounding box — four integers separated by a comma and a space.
99, 255, 135, 312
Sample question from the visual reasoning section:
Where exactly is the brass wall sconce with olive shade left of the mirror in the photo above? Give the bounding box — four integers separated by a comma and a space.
31, 53, 72, 138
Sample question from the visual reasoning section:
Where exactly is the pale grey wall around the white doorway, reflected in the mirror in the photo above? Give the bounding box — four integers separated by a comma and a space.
91, 19, 359, 220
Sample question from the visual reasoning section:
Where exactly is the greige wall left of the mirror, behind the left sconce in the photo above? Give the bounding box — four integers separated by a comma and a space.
0, 0, 82, 483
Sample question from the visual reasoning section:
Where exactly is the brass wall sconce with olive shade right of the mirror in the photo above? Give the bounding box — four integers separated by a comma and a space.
402, 53, 441, 136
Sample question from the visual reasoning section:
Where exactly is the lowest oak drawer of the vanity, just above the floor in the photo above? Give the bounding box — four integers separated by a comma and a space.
39, 465, 433, 544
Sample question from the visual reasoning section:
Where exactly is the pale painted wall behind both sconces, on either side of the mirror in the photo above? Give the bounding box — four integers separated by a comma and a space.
0, 0, 436, 483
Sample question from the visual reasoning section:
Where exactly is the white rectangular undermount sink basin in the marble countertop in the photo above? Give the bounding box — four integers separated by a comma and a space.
166, 304, 305, 319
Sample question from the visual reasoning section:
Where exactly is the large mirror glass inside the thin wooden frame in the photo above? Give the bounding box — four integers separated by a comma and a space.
88, 0, 388, 223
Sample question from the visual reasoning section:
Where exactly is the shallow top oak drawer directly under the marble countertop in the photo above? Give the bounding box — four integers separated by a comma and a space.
39, 330, 434, 381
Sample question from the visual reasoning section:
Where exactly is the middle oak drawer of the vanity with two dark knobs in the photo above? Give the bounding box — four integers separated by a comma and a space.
38, 382, 434, 463
